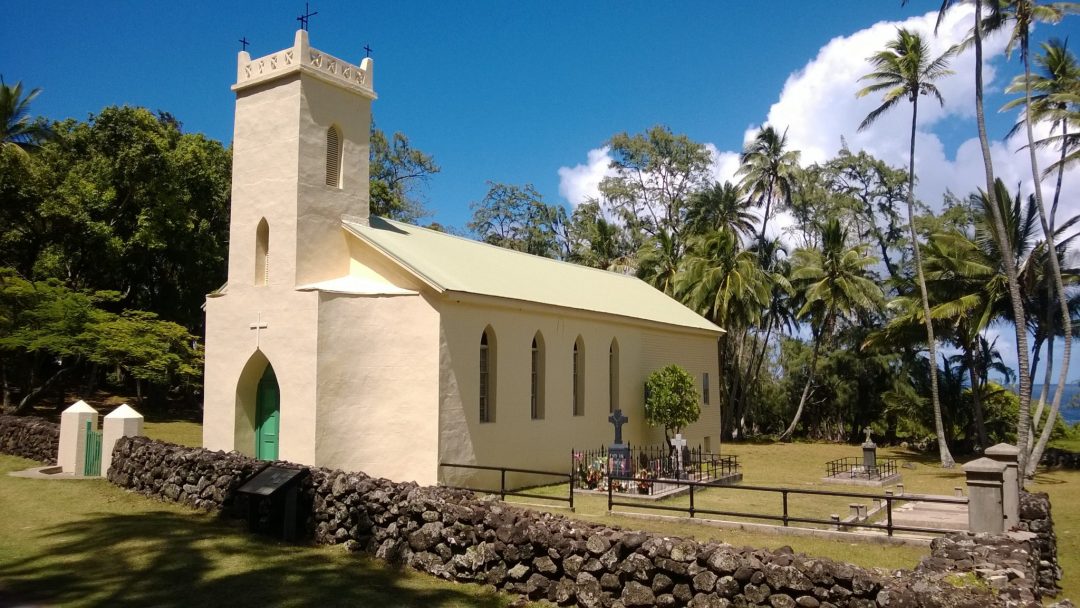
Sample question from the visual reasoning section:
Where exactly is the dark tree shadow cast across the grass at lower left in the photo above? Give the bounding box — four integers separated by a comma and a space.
0, 511, 505, 608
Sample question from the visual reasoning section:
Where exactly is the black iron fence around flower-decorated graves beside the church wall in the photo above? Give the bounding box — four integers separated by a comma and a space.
570, 446, 739, 496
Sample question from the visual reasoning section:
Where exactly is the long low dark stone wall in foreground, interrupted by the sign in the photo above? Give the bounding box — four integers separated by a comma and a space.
109, 437, 1058, 608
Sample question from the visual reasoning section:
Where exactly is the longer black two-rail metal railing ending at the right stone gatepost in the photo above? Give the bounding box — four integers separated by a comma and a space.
608, 476, 968, 536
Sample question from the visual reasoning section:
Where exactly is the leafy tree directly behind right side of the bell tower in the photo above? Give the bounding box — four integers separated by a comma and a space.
368, 124, 440, 224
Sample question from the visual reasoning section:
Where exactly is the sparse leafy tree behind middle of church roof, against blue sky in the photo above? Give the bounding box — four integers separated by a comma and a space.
468, 181, 568, 257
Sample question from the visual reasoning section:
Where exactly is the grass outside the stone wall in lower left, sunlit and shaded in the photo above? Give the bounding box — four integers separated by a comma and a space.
0, 456, 527, 608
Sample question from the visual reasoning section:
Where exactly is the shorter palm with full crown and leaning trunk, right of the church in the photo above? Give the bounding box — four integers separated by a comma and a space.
780, 219, 882, 440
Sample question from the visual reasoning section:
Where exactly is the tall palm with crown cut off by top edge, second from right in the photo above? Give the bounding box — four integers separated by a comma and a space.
937, 0, 1031, 487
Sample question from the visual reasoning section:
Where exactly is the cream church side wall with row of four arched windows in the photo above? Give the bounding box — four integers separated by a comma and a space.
438, 295, 719, 485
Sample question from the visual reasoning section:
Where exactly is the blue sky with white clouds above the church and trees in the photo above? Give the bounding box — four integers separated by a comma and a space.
0, 0, 1080, 376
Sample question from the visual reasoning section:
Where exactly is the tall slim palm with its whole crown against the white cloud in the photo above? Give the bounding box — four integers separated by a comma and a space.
856, 28, 956, 468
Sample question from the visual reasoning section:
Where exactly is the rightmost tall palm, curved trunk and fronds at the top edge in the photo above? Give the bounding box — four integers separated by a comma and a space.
990, 0, 1077, 475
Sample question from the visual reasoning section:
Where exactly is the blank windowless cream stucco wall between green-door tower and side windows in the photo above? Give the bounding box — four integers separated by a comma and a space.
315, 294, 438, 485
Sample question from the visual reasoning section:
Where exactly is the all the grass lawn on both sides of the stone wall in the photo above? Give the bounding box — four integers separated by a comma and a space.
14, 417, 1080, 607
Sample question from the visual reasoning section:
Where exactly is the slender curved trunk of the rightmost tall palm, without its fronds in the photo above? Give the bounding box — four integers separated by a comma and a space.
1021, 36, 1072, 476
